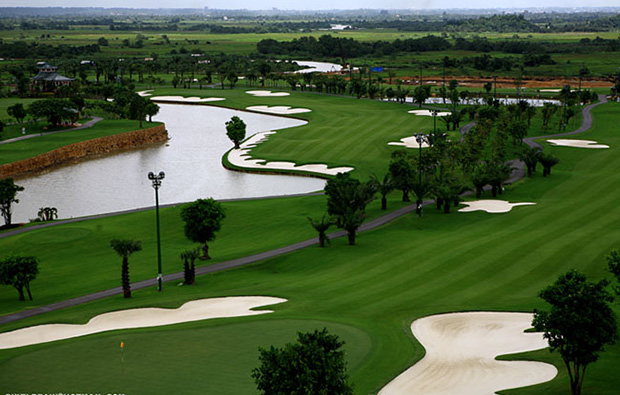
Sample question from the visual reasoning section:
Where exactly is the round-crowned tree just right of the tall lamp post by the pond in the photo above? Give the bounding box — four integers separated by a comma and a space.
181, 198, 226, 259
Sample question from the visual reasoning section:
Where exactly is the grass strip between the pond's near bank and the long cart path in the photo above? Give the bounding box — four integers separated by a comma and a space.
0, 195, 402, 314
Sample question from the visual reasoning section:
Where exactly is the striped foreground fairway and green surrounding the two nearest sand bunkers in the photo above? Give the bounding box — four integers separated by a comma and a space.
0, 103, 620, 395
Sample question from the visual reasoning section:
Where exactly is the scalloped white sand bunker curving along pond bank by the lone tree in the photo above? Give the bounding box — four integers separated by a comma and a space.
228, 132, 353, 176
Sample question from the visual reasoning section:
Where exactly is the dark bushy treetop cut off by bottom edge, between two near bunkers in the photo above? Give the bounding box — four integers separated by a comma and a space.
252, 329, 353, 395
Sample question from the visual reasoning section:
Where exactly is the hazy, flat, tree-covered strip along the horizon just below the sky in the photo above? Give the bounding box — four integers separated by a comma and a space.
0, 10, 620, 34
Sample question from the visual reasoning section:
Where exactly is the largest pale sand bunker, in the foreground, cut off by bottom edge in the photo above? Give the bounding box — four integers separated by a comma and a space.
379, 312, 558, 395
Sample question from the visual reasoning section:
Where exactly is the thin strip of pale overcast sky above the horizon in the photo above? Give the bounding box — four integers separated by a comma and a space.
0, 0, 620, 10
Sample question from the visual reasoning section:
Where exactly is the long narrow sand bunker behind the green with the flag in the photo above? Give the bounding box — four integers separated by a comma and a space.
0, 296, 286, 349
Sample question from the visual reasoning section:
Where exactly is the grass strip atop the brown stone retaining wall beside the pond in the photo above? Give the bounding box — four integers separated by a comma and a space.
0, 120, 159, 165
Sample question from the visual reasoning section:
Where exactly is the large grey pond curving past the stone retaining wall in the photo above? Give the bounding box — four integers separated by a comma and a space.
13, 104, 325, 223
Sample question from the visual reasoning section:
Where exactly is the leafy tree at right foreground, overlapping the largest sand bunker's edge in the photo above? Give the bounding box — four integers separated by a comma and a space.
532, 270, 618, 395
